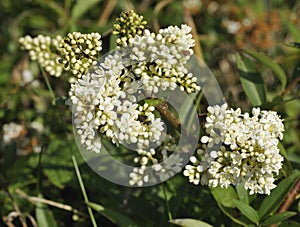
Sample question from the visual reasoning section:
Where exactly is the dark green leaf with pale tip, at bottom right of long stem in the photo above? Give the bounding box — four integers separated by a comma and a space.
87, 202, 137, 227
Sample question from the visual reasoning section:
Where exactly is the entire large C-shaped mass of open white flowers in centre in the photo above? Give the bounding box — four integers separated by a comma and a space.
70, 25, 200, 152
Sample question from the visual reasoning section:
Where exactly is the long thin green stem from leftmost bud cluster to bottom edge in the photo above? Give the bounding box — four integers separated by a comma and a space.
41, 68, 97, 227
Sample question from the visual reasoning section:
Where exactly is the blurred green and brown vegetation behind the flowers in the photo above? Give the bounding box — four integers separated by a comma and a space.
0, 0, 300, 226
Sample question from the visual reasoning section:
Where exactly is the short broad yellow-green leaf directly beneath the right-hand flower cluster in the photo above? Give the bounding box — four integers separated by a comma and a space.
211, 186, 238, 207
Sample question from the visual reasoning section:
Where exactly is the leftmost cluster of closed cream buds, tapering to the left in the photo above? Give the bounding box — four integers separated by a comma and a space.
19, 35, 64, 77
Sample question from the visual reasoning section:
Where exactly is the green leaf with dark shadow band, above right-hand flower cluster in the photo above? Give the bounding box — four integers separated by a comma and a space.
237, 54, 266, 106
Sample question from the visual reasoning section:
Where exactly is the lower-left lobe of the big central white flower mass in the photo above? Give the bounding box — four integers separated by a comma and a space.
69, 52, 164, 152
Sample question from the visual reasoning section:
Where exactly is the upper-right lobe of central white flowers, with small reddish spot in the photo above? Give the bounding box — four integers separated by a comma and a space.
129, 25, 200, 93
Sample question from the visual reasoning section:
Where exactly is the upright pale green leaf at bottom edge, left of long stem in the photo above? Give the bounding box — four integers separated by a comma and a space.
35, 194, 57, 227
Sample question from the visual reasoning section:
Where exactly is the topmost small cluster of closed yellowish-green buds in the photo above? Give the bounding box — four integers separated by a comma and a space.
113, 10, 147, 46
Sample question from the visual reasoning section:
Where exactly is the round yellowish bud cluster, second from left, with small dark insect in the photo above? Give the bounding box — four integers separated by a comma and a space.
59, 32, 102, 78
